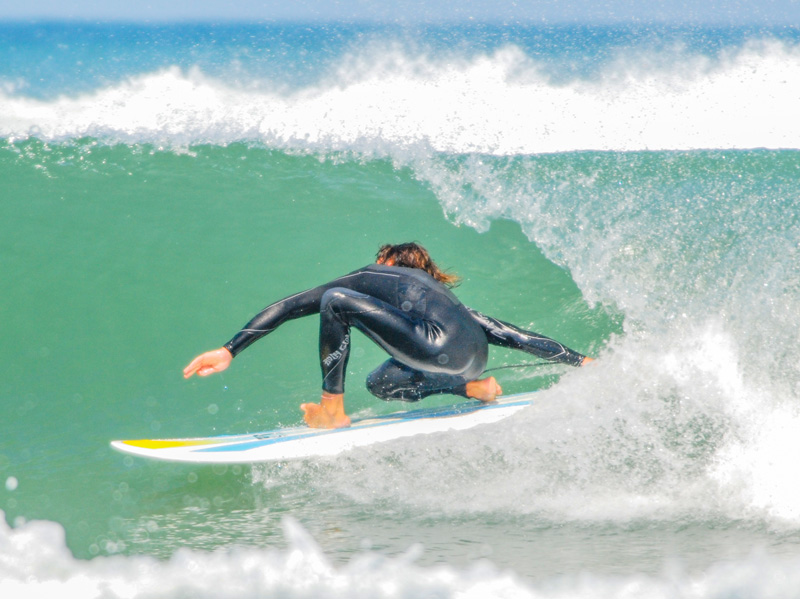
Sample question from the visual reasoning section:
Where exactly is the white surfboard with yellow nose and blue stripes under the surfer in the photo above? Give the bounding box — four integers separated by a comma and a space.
111, 393, 533, 464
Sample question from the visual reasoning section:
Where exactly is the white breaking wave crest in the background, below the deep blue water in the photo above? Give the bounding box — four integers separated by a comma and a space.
0, 40, 800, 155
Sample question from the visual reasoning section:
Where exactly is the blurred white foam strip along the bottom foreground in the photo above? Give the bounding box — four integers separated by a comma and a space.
0, 514, 800, 599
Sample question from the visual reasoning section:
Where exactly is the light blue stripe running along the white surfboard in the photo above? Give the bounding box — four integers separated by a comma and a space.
191, 399, 531, 453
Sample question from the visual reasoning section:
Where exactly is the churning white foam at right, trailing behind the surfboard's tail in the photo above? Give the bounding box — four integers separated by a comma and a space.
276, 320, 800, 530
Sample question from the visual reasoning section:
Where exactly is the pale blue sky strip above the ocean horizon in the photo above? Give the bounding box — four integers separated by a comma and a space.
0, 0, 800, 26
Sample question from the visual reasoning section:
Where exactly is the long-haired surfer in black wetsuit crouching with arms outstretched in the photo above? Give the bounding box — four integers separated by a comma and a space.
183, 243, 591, 428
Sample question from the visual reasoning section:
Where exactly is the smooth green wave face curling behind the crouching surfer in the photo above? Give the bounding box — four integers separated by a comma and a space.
0, 140, 619, 556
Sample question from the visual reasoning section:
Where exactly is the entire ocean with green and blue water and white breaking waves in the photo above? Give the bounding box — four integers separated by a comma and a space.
0, 22, 800, 599
